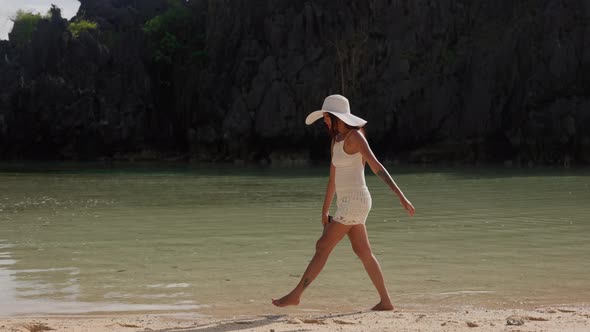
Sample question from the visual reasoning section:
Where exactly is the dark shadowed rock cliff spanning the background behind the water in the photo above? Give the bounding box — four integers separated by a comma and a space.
0, 0, 590, 164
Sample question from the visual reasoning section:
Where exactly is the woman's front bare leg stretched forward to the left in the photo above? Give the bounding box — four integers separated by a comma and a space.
272, 222, 351, 307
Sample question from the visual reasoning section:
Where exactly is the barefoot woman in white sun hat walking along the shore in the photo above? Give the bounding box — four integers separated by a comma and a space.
272, 95, 414, 310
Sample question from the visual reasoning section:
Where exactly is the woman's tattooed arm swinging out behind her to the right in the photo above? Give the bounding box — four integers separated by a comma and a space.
347, 130, 416, 216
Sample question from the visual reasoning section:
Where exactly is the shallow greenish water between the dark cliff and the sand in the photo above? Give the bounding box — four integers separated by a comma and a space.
0, 164, 590, 316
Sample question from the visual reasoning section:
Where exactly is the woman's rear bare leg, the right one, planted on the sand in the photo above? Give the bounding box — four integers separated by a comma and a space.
348, 225, 393, 310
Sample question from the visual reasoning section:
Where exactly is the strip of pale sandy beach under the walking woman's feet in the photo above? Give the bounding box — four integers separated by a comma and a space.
0, 304, 590, 332
